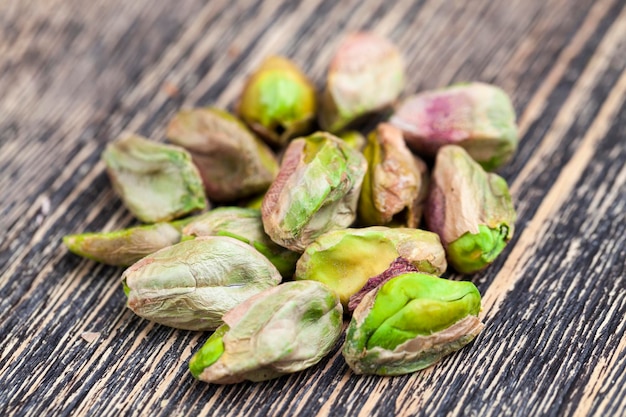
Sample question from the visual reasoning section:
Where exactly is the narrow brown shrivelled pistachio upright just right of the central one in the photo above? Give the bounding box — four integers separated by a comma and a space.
358, 123, 428, 228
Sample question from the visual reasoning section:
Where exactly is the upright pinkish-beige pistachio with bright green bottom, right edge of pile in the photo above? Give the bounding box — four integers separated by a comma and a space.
425, 145, 516, 274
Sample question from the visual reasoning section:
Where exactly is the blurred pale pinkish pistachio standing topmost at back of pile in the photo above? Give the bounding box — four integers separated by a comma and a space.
319, 32, 404, 132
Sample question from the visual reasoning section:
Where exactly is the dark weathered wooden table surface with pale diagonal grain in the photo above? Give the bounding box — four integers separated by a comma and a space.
0, 0, 626, 416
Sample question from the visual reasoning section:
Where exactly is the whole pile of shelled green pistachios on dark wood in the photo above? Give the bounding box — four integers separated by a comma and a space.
64, 33, 518, 384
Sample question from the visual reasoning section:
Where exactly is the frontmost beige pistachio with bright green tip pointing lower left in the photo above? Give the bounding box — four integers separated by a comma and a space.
189, 281, 343, 384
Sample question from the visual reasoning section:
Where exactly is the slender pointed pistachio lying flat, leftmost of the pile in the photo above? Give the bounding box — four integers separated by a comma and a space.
63, 223, 181, 266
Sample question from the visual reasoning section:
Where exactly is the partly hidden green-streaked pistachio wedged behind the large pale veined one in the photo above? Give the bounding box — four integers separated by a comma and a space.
183, 207, 300, 278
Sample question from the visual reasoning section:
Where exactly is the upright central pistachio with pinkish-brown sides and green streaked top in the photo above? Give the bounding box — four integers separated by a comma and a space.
261, 132, 367, 252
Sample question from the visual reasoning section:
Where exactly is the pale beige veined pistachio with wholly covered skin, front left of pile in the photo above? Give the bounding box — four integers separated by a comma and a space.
122, 236, 281, 330
